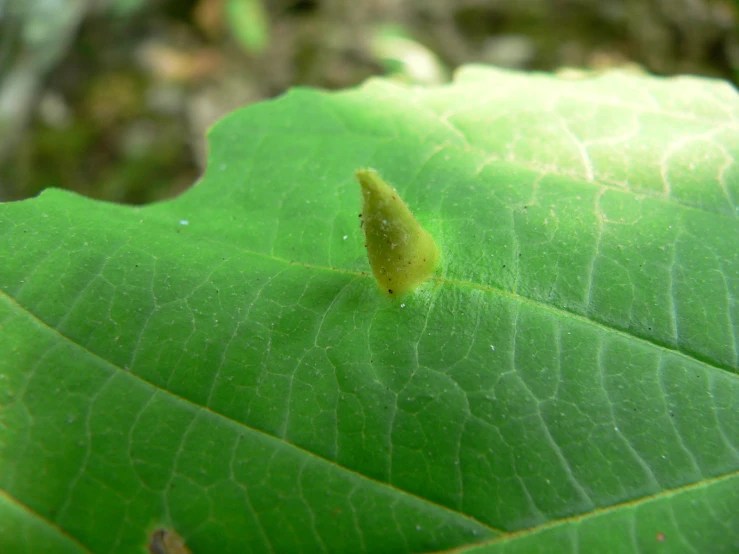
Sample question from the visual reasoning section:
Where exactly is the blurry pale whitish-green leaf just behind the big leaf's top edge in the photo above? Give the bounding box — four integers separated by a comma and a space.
372, 25, 449, 85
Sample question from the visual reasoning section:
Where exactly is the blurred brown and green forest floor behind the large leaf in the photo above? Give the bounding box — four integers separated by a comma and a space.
0, 0, 739, 204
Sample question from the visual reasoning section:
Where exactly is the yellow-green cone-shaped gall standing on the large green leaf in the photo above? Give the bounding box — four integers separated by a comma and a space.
356, 169, 439, 296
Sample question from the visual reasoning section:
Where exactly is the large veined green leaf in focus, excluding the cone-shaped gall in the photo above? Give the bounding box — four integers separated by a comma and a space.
0, 67, 739, 554
